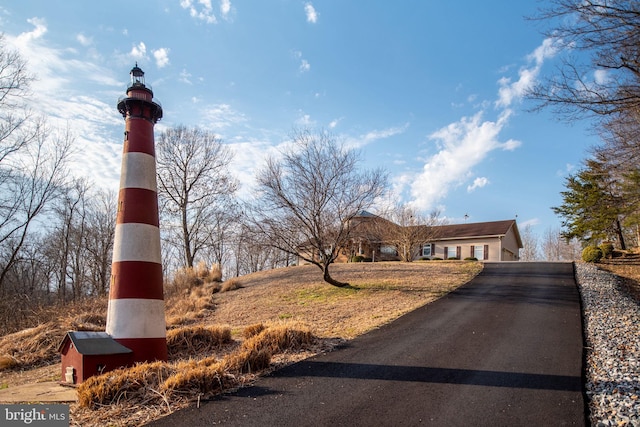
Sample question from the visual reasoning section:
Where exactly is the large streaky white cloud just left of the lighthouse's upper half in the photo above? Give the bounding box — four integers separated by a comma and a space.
5, 18, 127, 189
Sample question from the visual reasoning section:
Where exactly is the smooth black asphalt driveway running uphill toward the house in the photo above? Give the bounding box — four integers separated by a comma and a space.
150, 263, 585, 426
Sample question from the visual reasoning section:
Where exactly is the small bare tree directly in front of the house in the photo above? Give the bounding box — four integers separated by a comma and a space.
370, 204, 445, 262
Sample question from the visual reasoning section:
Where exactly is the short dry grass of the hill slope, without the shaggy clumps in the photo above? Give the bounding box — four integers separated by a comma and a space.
0, 261, 482, 425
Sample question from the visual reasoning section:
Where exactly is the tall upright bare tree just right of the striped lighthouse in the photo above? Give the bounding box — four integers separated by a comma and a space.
156, 126, 238, 267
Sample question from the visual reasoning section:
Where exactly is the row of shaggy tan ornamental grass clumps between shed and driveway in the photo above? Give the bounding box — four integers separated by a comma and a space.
78, 325, 315, 409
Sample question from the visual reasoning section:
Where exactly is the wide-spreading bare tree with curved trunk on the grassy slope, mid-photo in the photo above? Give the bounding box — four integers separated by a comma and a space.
252, 130, 387, 287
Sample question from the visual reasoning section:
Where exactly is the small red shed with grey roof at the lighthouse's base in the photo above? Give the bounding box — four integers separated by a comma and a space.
58, 331, 133, 384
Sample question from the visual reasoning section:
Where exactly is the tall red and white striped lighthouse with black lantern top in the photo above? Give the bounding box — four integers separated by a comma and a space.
106, 64, 167, 362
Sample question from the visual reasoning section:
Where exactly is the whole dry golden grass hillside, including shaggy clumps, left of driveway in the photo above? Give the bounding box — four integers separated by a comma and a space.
0, 261, 482, 426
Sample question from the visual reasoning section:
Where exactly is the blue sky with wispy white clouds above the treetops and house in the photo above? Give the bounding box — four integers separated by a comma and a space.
0, 0, 598, 234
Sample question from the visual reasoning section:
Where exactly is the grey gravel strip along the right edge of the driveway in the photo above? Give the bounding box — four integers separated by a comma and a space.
576, 263, 640, 427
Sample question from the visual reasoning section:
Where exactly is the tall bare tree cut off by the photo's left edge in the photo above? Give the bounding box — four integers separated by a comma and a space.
0, 35, 73, 330
